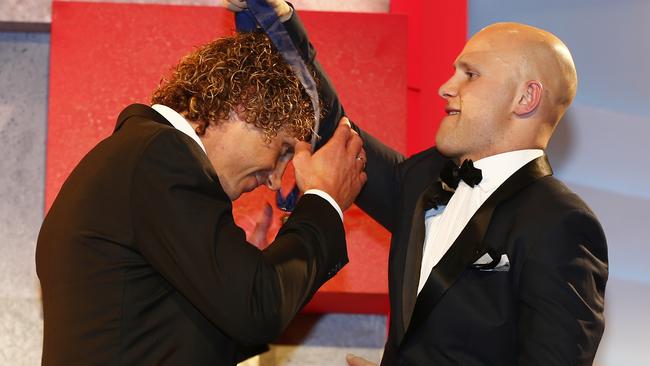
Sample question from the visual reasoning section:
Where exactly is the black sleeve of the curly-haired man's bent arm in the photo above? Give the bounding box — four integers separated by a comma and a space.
131, 130, 347, 343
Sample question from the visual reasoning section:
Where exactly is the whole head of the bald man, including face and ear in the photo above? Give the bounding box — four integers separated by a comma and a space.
436, 23, 577, 161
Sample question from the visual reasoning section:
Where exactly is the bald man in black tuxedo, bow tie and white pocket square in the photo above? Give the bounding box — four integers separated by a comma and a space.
336, 23, 608, 366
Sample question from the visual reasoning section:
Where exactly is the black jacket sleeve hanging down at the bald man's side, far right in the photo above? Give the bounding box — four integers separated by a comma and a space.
517, 210, 607, 366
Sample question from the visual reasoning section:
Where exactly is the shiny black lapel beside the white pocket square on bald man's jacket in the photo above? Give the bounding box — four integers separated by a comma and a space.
402, 156, 553, 344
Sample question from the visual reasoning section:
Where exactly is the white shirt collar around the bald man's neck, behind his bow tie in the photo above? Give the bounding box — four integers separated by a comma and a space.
474, 149, 544, 191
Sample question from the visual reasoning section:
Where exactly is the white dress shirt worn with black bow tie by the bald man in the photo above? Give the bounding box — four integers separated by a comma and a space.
418, 149, 544, 294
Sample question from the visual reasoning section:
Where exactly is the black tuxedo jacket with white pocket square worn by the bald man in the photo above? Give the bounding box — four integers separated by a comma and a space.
288, 12, 607, 366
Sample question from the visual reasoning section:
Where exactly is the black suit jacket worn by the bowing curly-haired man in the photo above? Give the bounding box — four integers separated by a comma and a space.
36, 105, 347, 366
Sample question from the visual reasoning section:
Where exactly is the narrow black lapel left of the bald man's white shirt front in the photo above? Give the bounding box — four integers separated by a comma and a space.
394, 182, 440, 338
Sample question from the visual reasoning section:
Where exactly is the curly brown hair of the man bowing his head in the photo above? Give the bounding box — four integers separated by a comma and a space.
151, 32, 316, 141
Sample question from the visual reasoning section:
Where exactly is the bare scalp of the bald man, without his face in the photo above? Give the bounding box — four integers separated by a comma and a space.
468, 22, 578, 124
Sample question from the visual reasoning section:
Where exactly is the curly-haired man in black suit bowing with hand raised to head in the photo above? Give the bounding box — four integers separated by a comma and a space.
36, 4, 366, 365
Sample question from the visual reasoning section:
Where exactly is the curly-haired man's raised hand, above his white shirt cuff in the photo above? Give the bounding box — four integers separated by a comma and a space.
293, 117, 368, 210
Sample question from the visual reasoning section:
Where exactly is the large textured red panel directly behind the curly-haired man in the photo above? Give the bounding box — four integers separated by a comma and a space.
46, 2, 406, 313
